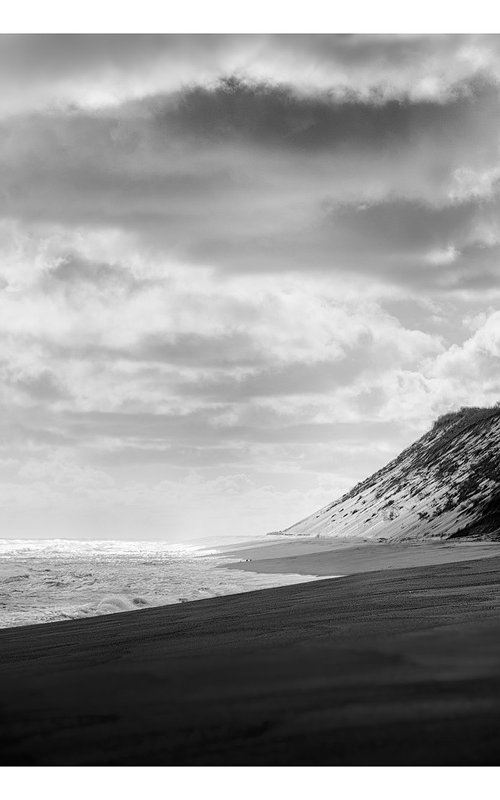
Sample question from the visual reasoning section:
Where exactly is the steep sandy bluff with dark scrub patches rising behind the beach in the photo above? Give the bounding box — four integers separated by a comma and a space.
274, 405, 500, 542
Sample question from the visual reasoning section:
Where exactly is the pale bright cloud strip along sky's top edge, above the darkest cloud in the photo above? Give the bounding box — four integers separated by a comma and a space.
0, 34, 499, 110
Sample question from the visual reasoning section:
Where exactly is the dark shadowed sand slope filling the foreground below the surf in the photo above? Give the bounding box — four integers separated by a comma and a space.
0, 557, 500, 765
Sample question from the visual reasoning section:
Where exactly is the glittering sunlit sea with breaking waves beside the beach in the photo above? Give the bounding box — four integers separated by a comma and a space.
0, 539, 320, 628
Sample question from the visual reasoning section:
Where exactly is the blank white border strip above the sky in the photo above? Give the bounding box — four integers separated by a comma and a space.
0, 0, 500, 33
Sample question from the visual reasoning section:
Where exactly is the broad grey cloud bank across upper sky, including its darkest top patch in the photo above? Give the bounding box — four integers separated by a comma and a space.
0, 73, 499, 286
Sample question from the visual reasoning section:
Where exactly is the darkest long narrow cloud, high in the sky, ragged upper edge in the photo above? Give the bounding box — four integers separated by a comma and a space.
157, 77, 498, 151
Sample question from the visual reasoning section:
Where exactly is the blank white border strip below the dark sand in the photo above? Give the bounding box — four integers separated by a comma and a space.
1, 764, 498, 800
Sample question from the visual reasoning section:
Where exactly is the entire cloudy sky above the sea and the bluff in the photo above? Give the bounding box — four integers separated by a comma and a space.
0, 35, 500, 542
